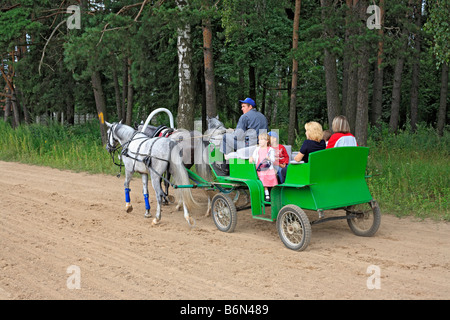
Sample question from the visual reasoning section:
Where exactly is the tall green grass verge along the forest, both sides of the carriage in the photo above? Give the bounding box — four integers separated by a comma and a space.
0, 120, 450, 221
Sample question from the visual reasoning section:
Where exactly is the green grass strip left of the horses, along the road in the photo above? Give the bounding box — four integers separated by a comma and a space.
0, 121, 117, 174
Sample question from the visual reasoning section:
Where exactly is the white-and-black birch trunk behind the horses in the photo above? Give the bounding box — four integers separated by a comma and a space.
176, 0, 194, 130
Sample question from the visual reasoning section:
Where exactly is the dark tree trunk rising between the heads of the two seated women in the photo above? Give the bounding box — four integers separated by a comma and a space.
320, 0, 341, 128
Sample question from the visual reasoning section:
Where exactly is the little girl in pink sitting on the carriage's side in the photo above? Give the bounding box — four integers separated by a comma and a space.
249, 133, 278, 201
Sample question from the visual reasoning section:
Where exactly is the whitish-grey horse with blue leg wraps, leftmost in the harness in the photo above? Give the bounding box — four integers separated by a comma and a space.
106, 122, 198, 226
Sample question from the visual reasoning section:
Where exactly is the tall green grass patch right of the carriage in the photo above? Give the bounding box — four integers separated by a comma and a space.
368, 127, 450, 221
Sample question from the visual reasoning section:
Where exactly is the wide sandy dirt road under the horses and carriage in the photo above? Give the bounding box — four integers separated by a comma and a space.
0, 162, 450, 300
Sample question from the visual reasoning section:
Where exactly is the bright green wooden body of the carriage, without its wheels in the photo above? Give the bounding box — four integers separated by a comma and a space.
210, 147, 372, 220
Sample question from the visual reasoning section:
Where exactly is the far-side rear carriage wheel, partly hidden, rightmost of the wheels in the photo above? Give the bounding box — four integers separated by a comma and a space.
346, 200, 381, 237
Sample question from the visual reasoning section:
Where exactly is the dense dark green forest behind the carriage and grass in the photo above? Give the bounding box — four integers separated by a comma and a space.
0, 0, 450, 145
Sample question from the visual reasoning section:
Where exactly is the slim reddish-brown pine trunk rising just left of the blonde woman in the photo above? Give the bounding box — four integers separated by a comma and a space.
288, 0, 301, 145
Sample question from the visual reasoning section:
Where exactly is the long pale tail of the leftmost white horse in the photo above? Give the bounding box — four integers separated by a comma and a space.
169, 141, 200, 211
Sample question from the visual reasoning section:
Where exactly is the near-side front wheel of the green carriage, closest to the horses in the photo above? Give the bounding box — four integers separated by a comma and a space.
211, 193, 237, 232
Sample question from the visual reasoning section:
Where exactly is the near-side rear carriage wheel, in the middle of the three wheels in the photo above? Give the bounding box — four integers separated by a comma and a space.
277, 204, 311, 251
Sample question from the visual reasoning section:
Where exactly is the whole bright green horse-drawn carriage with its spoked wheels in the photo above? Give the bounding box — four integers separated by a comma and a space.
185, 144, 381, 251
